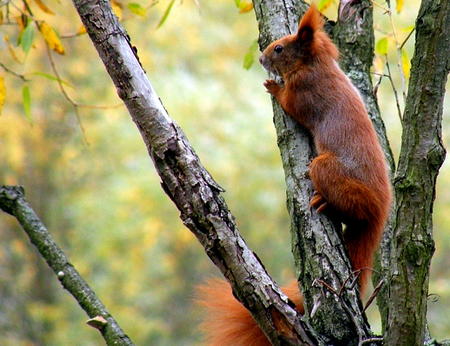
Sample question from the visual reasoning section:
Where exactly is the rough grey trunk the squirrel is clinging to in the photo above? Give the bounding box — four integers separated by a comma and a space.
253, 0, 370, 345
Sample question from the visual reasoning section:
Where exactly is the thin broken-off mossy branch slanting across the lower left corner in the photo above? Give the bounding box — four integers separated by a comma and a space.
0, 186, 133, 346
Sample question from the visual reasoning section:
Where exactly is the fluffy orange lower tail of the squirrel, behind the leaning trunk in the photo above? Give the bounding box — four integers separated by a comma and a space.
197, 279, 304, 346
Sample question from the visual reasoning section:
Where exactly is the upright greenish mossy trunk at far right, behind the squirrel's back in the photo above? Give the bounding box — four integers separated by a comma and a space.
382, 0, 450, 345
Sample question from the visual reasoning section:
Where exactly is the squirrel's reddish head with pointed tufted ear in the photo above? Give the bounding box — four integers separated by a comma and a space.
259, 4, 339, 77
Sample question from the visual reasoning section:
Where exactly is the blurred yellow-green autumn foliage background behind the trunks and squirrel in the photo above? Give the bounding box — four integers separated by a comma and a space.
0, 0, 450, 345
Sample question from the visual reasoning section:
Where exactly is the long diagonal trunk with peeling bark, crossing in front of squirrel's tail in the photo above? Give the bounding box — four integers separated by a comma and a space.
70, 0, 322, 345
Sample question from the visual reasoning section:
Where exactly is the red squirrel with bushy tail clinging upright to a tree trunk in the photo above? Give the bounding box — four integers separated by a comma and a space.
200, 5, 391, 346
